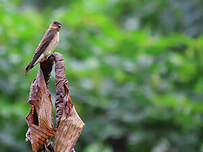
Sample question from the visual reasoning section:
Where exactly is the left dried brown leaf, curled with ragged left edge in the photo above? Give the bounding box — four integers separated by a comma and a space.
26, 69, 54, 152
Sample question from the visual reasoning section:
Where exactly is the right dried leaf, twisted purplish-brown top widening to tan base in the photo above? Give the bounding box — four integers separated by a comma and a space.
54, 53, 84, 152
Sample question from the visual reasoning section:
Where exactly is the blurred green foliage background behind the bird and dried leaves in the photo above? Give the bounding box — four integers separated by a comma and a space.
0, 0, 203, 152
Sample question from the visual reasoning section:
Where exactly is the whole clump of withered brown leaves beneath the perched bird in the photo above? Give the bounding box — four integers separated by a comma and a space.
26, 53, 84, 152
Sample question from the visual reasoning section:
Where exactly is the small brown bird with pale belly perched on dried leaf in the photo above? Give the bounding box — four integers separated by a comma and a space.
25, 21, 62, 74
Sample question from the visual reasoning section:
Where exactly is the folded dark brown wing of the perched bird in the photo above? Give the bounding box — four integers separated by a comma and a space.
26, 29, 57, 72
